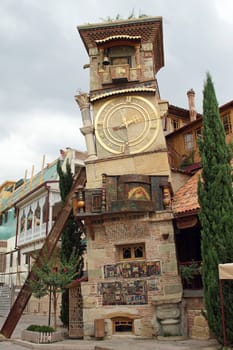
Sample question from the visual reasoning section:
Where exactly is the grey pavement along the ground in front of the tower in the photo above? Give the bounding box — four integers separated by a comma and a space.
0, 314, 219, 350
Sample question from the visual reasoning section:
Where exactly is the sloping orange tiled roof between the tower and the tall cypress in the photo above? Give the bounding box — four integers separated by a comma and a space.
172, 170, 201, 216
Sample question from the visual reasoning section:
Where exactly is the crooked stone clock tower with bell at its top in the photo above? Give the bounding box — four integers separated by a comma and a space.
73, 17, 182, 339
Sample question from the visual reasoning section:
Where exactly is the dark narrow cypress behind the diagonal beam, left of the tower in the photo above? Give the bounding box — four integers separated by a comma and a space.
57, 162, 86, 327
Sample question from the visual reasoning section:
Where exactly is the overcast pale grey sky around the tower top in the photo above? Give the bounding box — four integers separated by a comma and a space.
0, 0, 233, 184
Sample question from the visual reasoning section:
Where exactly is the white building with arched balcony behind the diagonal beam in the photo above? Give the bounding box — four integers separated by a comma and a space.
0, 148, 86, 313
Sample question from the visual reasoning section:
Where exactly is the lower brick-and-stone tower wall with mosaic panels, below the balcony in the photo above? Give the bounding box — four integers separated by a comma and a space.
82, 211, 182, 339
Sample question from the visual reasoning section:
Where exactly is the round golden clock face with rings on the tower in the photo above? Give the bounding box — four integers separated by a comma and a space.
95, 96, 159, 154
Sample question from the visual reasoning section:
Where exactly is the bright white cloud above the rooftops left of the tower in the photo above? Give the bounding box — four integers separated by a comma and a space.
0, 111, 85, 183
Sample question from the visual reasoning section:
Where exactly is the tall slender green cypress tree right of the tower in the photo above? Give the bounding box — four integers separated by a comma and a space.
198, 74, 233, 343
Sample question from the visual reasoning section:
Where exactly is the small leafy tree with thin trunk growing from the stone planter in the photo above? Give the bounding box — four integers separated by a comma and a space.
30, 254, 77, 330
